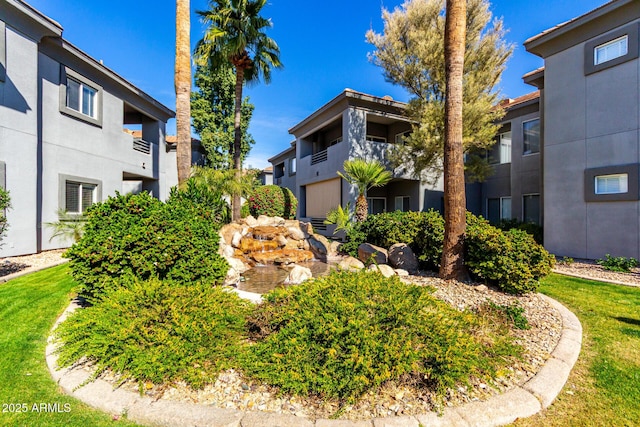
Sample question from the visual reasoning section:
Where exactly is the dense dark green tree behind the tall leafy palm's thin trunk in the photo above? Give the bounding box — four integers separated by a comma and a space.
191, 65, 255, 169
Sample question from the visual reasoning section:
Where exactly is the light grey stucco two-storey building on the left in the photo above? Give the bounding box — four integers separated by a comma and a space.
0, 0, 177, 257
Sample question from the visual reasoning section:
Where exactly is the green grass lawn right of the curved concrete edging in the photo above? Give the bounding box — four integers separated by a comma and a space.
515, 275, 640, 426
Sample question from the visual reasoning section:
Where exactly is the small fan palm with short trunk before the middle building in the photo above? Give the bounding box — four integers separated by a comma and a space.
338, 159, 392, 222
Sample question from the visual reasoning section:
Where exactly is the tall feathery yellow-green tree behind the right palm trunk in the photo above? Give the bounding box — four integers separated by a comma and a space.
367, 0, 513, 181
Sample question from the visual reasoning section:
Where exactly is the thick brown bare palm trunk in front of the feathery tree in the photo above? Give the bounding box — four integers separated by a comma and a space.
440, 0, 468, 280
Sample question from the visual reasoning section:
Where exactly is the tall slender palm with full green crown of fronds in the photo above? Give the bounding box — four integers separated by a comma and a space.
198, 0, 282, 220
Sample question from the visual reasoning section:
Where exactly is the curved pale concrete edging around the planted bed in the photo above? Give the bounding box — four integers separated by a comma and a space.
46, 295, 582, 427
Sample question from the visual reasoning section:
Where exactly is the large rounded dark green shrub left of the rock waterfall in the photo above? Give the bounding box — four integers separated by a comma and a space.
65, 193, 228, 300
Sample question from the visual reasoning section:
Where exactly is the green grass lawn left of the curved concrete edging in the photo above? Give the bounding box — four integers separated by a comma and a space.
0, 265, 136, 427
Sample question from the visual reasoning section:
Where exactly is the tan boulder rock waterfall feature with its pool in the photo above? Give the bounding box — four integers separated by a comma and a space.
220, 216, 338, 293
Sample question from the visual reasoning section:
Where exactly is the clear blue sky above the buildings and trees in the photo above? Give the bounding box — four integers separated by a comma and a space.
26, 0, 606, 168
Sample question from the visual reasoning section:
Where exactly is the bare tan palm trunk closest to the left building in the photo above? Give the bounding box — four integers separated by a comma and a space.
174, 0, 191, 184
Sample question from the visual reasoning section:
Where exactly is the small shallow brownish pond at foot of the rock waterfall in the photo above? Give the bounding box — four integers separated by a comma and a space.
237, 261, 334, 294
